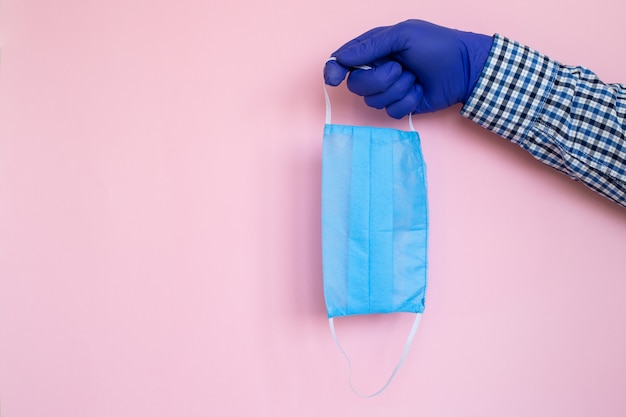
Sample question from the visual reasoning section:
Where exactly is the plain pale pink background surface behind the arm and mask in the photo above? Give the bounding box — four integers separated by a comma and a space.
0, 0, 626, 417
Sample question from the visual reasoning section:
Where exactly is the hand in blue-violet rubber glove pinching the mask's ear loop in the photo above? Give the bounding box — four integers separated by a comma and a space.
324, 20, 493, 119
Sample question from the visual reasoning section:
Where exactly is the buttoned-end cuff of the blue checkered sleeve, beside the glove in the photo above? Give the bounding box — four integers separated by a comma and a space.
461, 34, 559, 144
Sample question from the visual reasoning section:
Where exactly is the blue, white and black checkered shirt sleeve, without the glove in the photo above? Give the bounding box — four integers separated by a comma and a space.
461, 35, 626, 207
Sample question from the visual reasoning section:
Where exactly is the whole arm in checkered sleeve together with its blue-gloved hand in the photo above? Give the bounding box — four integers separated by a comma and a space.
325, 21, 626, 207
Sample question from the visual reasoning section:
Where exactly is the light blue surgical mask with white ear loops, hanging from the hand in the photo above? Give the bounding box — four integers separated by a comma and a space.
322, 83, 428, 397
